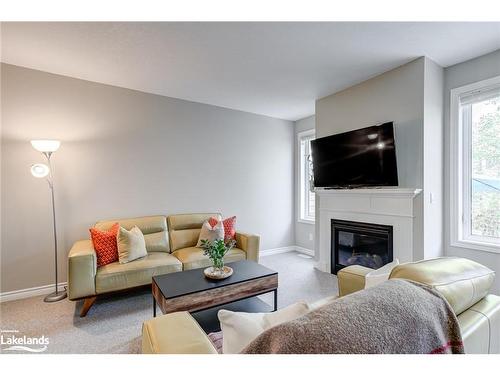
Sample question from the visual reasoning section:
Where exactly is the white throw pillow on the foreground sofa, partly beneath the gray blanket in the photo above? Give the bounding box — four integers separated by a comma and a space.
217, 302, 310, 354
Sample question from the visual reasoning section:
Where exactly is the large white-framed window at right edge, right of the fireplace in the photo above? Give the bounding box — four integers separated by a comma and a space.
450, 77, 500, 252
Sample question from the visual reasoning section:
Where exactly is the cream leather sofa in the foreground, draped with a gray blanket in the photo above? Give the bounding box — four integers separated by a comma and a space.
142, 258, 500, 354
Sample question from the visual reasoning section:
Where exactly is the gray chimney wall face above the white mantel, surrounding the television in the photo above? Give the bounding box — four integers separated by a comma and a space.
316, 58, 425, 188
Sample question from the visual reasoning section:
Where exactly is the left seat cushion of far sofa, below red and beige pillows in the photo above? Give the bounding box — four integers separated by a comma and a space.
95, 252, 182, 294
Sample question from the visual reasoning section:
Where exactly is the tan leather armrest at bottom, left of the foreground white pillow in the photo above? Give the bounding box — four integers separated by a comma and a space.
142, 311, 217, 354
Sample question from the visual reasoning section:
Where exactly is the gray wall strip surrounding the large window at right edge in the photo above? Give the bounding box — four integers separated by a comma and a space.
444, 50, 500, 294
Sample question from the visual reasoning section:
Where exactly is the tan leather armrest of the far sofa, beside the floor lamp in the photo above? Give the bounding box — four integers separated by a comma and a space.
68, 240, 97, 300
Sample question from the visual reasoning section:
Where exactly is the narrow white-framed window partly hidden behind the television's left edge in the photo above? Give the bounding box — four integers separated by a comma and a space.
298, 130, 315, 223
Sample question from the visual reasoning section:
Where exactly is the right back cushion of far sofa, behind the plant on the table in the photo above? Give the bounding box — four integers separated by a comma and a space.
167, 213, 221, 251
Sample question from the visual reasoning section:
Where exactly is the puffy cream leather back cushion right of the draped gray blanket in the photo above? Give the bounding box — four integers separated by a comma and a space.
389, 257, 495, 315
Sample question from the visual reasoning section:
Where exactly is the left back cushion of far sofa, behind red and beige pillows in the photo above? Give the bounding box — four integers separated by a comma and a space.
95, 216, 170, 252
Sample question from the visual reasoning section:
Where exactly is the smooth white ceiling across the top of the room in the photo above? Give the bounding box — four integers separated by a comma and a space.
1, 22, 500, 120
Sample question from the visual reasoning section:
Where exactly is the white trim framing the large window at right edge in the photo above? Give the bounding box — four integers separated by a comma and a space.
450, 76, 500, 253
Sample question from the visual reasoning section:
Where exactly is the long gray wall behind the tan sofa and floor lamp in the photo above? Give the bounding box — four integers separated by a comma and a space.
1, 64, 295, 292
